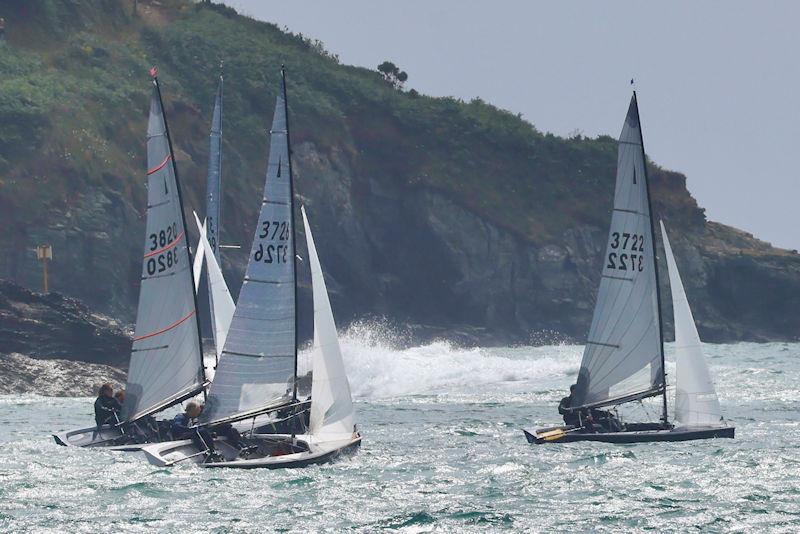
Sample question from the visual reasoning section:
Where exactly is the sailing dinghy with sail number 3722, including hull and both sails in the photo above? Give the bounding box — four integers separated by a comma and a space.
523, 92, 734, 444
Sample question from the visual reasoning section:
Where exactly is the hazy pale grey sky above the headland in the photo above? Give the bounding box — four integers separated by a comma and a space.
219, 0, 800, 249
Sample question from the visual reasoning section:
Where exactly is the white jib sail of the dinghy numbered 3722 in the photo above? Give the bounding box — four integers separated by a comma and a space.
661, 221, 722, 426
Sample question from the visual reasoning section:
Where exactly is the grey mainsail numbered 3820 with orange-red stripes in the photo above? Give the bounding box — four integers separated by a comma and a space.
124, 82, 204, 420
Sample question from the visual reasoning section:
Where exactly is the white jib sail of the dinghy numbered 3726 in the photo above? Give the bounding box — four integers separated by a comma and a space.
300, 207, 354, 440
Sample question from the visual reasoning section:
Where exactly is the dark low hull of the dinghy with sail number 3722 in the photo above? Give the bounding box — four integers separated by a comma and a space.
523, 426, 736, 445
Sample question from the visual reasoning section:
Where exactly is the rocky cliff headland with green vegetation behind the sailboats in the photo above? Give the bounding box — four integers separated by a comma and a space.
0, 0, 800, 343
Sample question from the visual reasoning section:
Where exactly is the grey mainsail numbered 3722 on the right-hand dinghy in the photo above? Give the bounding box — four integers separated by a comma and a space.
573, 95, 664, 407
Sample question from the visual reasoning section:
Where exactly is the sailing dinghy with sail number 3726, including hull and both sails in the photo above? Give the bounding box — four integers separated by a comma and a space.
143, 70, 361, 468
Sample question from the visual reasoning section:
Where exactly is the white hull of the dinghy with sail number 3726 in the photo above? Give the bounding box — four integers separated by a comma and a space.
142, 434, 361, 469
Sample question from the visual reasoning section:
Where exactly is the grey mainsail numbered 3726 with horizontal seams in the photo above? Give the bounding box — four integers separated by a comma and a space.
206, 82, 296, 428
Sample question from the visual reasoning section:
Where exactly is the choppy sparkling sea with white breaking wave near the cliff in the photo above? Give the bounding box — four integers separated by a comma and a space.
0, 330, 800, 533
